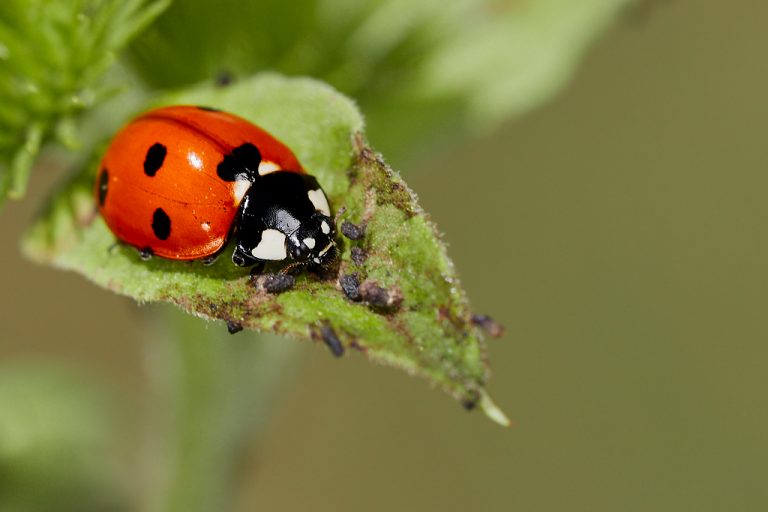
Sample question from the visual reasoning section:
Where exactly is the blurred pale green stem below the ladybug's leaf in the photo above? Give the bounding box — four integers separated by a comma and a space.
143, 307, 298, 512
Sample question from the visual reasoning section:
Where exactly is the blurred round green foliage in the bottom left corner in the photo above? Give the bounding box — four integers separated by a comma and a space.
0, 364, 128, 512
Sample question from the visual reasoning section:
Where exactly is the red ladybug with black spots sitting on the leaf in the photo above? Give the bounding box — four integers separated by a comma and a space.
95, 106, 336, 267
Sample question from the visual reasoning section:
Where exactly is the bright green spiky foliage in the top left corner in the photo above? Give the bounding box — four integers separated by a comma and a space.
0, 0, 169, 204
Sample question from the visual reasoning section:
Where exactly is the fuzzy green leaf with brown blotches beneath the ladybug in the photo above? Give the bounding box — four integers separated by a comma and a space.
25, 75, 505, 423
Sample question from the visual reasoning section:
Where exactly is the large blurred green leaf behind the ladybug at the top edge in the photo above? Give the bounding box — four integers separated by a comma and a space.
129, 0, 630, 159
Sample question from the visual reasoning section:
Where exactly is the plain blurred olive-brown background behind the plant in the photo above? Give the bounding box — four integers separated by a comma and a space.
0, 0, 768, 512
